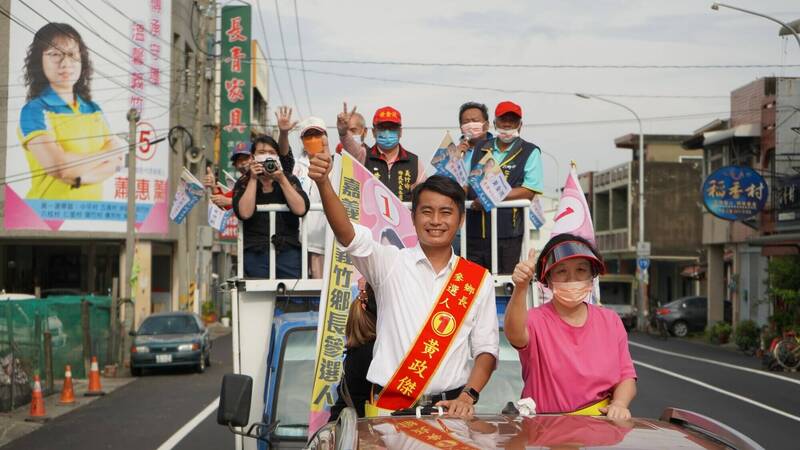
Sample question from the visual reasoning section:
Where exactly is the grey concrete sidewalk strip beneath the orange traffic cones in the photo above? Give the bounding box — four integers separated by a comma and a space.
0, 376, 135, 447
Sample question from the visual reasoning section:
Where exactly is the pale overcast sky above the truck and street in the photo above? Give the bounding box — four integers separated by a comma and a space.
253, 0, 800, 194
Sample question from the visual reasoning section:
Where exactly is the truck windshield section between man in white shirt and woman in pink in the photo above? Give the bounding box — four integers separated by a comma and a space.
475, 328, 522, 414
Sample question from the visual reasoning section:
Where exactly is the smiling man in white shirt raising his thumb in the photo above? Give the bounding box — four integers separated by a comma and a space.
309, 152, 499, 417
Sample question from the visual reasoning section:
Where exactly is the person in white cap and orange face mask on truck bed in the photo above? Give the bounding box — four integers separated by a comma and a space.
294, 117, 329, 278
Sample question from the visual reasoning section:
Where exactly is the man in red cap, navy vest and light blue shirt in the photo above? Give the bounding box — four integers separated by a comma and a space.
467, 101, 543, 273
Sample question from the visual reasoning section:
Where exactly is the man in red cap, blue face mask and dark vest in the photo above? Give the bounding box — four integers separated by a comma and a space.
337, 103, 425, 201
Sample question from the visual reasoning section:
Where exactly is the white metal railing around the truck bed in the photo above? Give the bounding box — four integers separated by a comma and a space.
236, 200, 532, 281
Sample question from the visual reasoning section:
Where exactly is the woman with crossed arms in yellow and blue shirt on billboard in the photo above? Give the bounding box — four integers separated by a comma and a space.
19, 23, 126, 200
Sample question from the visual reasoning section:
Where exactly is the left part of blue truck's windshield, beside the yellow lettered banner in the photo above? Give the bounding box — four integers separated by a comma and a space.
273, 328, 317, 439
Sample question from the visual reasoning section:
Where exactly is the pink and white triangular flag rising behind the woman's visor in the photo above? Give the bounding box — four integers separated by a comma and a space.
550, 165, 596, 245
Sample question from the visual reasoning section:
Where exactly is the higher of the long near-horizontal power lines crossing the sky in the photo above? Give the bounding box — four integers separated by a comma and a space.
260, 58, 800, 70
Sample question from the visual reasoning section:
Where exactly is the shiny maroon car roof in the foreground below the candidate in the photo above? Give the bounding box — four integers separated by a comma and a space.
356, 415, 748, 449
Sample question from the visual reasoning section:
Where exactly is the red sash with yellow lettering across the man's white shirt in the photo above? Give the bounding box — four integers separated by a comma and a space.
375, 258, 487, 411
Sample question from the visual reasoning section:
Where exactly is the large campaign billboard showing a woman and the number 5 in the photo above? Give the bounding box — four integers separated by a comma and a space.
4, 0, 172, 234
